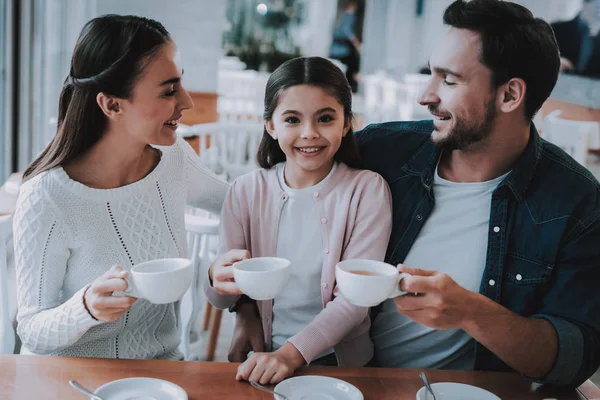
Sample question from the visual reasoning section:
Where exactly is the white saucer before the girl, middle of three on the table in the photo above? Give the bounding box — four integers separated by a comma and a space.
275, 376, 364, 400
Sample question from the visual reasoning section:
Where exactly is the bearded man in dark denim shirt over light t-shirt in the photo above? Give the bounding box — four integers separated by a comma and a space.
221, 0, 600, 387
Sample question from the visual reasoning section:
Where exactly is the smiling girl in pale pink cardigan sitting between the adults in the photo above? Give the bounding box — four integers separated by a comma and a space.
205, 57, 392, 384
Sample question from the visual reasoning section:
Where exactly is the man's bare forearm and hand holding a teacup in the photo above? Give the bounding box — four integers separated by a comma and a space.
396, 267, 558, 378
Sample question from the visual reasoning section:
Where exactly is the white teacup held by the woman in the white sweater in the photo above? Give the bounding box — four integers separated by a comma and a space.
115, 258, 194, 304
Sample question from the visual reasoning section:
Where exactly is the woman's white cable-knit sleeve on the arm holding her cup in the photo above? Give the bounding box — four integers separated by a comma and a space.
13, 182, 102, 354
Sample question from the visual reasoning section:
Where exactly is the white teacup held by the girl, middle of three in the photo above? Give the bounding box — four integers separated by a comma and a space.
233, 257, 292, 300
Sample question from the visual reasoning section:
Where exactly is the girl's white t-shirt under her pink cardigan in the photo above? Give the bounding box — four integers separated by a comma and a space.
272, 163, 337, 358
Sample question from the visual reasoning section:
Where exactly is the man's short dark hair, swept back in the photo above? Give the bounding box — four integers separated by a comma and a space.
444, 0, 560, 120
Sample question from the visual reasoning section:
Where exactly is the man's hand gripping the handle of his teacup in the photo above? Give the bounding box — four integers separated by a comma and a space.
395, 265, 481, 329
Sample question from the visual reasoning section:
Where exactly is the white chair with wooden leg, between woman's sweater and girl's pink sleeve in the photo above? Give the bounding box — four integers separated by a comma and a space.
181, 214, 222, 361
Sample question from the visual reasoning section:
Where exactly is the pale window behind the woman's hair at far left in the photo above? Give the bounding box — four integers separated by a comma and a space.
14, 0, 97, 170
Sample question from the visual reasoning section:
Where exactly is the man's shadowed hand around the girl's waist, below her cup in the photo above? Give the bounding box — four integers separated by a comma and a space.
227, 300, 265, 363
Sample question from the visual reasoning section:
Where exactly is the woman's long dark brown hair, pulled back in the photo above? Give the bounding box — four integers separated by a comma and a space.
24, 15, 170, 180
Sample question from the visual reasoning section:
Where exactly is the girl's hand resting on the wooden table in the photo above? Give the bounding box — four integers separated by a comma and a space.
235, 342, 304, 385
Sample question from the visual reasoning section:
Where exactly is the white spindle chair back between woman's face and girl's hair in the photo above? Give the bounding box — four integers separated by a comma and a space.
193, 122, 264, 180
